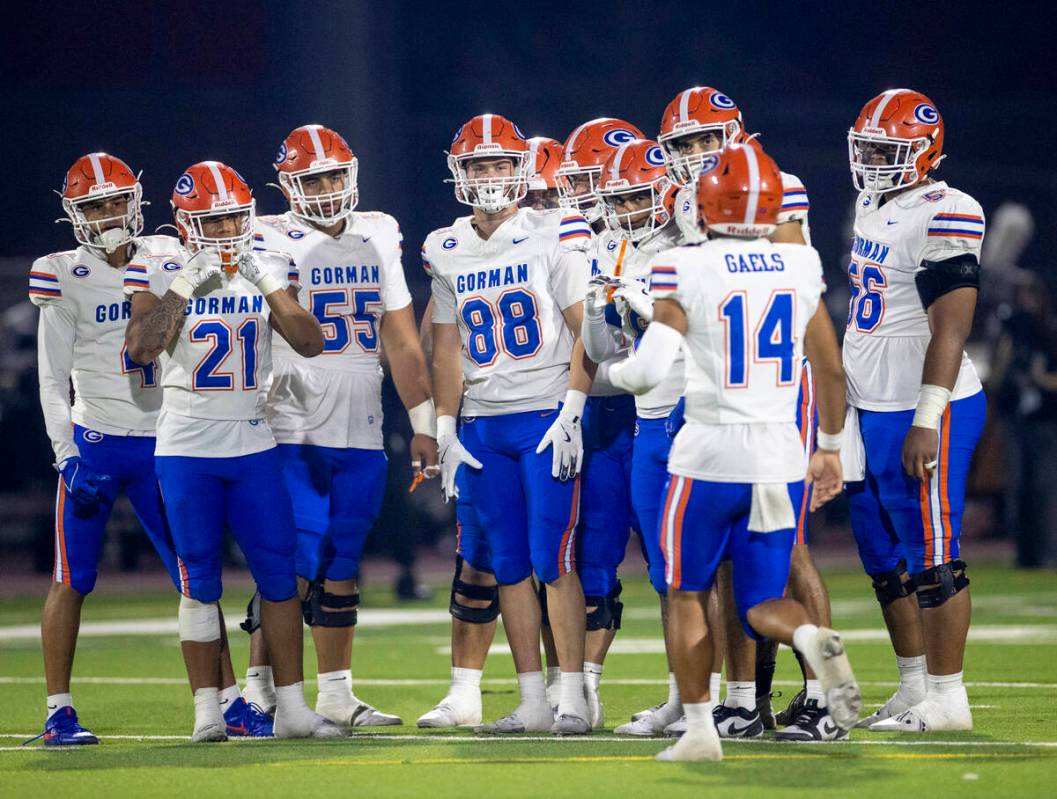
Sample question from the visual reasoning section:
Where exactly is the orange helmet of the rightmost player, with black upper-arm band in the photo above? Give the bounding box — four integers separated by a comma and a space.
848, 89, 944, 193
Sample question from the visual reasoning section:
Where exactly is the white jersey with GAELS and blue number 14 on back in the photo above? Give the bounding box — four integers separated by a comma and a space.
650, 238, 824, 483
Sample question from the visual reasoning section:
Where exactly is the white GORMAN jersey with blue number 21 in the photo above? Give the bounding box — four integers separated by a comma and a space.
125, 246, 296, 458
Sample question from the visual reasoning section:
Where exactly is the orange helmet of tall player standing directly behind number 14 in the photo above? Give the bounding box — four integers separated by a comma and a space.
657, 86, 745, 186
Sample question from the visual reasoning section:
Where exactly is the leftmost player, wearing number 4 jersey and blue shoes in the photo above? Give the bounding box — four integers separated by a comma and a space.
30, 152, 272, 746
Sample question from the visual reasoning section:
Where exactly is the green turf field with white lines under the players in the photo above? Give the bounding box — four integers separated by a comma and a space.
0, 568, 1057, 799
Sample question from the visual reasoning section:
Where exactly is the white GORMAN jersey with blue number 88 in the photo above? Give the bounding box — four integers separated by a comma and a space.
423, 208, 591, 416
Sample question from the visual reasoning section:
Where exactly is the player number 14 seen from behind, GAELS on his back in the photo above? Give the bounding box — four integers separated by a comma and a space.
610, 145, 859, 760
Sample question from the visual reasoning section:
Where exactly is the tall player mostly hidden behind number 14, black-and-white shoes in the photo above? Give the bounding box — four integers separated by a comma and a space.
657, 87, 843, 740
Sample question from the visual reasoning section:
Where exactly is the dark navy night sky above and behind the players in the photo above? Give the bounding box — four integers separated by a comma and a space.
0, 0, 1057, 574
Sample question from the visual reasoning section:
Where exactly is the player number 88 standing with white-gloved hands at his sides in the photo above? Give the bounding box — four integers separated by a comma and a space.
424, 114, 591, 735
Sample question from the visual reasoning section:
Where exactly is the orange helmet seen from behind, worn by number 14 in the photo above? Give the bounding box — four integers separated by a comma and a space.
698, 144, 782, 239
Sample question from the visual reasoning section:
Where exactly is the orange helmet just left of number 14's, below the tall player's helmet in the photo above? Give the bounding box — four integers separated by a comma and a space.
595, 138, 675, 241
